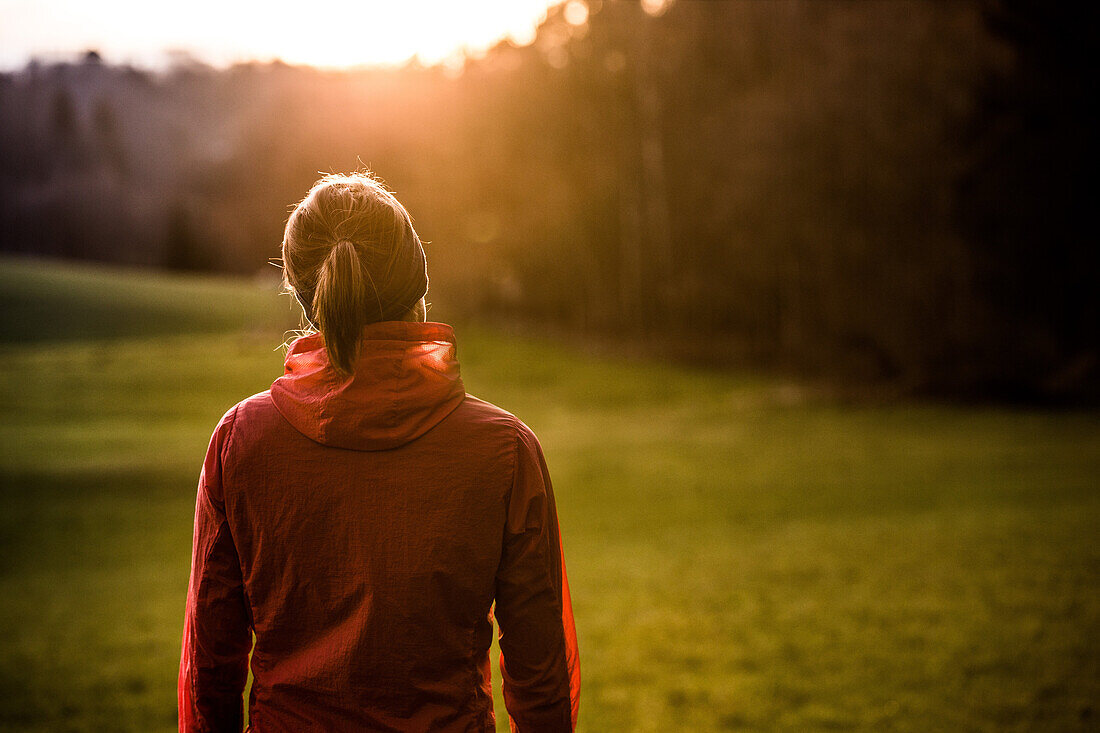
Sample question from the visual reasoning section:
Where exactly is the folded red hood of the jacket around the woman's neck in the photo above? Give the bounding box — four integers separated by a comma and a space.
271, 320, 465, 450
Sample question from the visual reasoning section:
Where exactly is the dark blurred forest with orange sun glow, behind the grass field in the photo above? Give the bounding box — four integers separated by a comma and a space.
0, 0, 1100, 405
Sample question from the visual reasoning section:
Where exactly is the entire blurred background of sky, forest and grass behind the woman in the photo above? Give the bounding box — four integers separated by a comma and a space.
0, 0, 1100, 731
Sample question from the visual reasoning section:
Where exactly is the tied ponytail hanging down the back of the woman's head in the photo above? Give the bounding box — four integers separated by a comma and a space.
311, 239, 378, 376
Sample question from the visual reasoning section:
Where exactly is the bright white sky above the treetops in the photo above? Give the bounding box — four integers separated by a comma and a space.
0, 0, 560, 69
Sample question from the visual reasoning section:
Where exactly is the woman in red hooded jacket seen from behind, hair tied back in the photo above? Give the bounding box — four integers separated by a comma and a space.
178, 174, 580, 733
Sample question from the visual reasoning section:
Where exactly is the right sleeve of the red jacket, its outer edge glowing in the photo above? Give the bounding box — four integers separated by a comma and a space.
495, 426, 581, 733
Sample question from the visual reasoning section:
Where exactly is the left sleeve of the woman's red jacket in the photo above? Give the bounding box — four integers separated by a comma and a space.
177, 408, 252, 733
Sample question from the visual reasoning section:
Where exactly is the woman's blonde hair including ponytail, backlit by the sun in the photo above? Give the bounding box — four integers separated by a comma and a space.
283, 173, 428, 375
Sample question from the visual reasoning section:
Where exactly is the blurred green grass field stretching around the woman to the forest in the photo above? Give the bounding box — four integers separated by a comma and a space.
0, 254, 1100, 732
